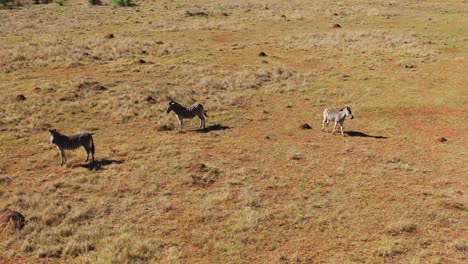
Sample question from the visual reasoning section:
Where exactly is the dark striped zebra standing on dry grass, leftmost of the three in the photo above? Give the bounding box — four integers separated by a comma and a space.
49, 129, 94, 166
